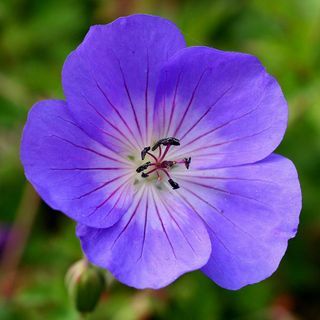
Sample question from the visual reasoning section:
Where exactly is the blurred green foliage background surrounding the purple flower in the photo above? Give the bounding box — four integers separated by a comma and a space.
0, 0, 320, 320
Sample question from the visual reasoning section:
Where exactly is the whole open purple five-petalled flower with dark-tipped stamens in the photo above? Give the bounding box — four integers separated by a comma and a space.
21, 15, 301, 289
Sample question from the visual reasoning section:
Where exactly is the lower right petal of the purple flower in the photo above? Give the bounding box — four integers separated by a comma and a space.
175, 154, 301, 289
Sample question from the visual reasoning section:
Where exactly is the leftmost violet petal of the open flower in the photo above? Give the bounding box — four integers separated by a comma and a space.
21, 100, 133, 227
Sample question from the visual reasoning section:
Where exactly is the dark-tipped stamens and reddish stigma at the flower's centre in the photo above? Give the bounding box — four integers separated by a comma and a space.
136, 137, 191, 190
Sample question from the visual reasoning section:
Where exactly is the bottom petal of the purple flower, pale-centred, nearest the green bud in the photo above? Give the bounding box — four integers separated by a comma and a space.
77, 187, 211, 289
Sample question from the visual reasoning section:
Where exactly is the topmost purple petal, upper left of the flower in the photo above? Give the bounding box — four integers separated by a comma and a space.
62, 15, 185, 150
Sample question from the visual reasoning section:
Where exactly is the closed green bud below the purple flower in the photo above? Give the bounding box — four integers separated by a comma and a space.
66, 259, 106, 313
